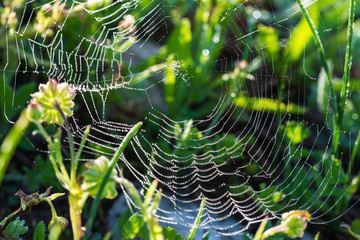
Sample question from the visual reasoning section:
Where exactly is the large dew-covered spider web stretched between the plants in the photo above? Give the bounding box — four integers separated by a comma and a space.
0, 0, 357, 236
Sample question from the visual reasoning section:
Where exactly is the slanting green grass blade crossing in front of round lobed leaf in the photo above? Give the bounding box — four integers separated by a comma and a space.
85, 122, 142, 239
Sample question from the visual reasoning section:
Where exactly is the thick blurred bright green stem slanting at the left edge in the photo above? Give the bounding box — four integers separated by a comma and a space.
0, 110, 29, 185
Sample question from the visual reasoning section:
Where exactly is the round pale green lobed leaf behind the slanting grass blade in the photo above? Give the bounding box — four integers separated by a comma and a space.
81, 156, 117, 199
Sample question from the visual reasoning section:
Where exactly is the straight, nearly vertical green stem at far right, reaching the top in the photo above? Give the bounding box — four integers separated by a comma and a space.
334, 0, 355, 155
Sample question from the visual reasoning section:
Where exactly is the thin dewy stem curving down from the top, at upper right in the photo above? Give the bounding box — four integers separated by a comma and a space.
296, 0, 338, 154
